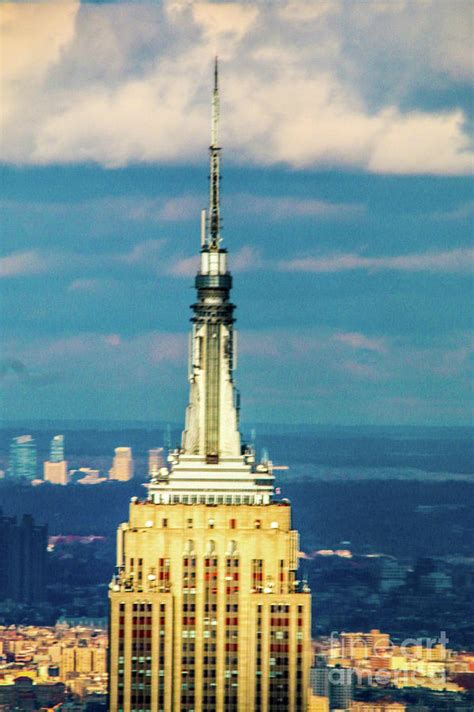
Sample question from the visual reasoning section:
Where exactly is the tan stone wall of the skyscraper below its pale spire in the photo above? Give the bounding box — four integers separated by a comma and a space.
110, 502, 311, 712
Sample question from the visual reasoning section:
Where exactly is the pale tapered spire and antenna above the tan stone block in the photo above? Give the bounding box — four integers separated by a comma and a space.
150, 60, 273, 504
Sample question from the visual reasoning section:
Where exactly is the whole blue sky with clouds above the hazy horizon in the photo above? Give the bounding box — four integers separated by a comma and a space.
0, 0, 474, 425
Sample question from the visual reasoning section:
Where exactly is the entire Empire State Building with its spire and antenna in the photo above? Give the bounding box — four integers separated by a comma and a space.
109, 62, 311, 712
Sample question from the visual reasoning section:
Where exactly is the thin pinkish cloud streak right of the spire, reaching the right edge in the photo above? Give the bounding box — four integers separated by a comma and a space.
280, 248, 474, 272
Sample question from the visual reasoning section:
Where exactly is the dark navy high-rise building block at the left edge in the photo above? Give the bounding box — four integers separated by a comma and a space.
0, 510, 48, 603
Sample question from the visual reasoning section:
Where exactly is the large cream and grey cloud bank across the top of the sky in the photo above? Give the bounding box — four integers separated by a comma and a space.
2, 0, 473, 173
